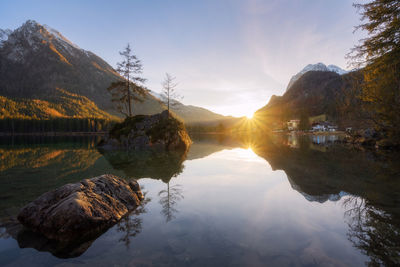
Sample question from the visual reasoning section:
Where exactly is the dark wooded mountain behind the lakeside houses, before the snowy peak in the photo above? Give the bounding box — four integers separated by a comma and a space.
254, 71, 362, 128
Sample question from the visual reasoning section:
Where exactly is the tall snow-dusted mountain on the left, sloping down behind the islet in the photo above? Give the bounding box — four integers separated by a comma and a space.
0, 20, 231, 123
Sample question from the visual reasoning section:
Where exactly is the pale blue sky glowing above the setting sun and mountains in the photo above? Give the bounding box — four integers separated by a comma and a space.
0, 0, 363, 117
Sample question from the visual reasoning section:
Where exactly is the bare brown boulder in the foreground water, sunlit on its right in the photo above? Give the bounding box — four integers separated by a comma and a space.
18, 174, 143, 244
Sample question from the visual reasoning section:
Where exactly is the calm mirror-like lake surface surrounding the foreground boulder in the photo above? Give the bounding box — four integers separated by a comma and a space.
0, 135, 400, 266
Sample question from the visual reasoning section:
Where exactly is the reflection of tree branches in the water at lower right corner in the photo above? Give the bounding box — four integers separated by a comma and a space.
344, 196, 400, 266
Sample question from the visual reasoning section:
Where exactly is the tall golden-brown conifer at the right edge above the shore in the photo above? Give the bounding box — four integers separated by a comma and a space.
349, 0, 400, 141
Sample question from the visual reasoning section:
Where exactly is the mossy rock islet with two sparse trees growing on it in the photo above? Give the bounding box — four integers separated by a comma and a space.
99, 111, 192, 151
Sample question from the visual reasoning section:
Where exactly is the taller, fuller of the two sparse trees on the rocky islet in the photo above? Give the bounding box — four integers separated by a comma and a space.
107, 44, 147, 117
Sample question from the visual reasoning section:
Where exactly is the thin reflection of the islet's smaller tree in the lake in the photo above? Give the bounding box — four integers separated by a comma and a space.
158, 182, 184, 222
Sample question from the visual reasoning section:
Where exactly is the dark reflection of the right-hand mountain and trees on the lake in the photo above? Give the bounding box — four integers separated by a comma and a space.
233, 133, 400, 266
